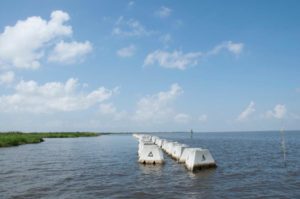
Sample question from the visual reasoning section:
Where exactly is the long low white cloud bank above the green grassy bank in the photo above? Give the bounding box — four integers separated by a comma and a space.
0, 78, 115, 113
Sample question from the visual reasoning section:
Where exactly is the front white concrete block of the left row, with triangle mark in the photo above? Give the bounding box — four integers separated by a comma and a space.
139, 143, 164, 164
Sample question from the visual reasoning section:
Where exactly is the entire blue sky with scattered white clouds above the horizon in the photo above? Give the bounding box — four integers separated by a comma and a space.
0, 0, 300, 132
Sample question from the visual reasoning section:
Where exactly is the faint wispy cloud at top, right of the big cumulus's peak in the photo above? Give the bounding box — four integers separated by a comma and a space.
112, 16, 153, 36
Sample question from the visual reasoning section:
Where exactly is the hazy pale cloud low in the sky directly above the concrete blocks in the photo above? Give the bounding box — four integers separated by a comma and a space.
133, 84, 183, 123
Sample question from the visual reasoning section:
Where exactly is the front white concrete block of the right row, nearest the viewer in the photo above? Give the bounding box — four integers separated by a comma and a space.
185, 148, 216, 171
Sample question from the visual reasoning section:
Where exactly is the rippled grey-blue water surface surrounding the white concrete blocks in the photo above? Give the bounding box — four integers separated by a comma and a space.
0, 132, 300, 199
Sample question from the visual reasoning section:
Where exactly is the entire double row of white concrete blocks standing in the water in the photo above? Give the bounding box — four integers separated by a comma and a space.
133, 134, 217, 171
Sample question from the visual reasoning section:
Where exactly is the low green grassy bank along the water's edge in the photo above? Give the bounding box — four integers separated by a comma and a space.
0, 132, 100, 147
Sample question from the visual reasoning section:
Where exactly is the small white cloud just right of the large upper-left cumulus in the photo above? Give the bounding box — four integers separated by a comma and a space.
48, 41, 93, 64
